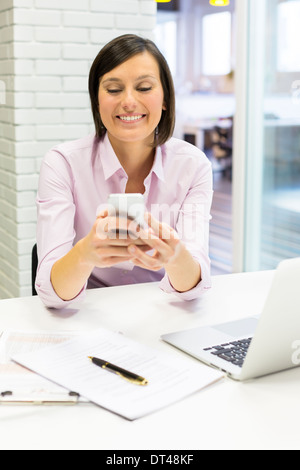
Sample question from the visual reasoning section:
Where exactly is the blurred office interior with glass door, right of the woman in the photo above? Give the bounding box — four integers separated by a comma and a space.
155, 0, 300, 274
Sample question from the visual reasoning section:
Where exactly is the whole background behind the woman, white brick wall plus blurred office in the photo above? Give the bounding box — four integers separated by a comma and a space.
0, 0, 300, 298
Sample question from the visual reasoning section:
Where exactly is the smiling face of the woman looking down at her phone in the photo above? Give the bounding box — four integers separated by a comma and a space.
98, 52, 166, 145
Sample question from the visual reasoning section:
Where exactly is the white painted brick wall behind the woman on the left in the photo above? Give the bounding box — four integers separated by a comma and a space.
0, 0, 156, 298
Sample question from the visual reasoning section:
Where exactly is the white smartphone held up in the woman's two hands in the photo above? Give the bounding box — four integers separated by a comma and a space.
107, 193, 145, 227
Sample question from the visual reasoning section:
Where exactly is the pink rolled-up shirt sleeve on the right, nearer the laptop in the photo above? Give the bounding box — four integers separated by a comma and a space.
159, 155, 213, 301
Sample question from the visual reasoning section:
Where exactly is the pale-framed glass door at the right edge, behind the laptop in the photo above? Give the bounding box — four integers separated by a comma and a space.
234, 0, 300, 271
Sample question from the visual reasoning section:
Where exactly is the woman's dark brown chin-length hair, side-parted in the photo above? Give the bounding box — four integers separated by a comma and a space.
89, 34, 175, 147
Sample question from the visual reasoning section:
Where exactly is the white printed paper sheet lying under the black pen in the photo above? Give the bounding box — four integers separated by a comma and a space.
12, 329, 223, 420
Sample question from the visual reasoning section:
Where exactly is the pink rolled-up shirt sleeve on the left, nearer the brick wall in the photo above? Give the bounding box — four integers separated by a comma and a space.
35, 149, 86, 308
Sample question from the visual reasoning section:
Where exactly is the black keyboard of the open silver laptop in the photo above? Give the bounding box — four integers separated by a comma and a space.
204, 338, 252, 367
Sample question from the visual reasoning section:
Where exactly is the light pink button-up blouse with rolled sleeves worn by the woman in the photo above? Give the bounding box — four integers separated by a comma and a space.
36, 135, 213, 308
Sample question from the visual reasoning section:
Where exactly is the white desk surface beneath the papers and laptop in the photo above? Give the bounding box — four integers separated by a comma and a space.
0, 272, 300, 450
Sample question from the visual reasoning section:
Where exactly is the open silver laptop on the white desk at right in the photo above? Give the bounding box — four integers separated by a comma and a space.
162, 258, 300, 381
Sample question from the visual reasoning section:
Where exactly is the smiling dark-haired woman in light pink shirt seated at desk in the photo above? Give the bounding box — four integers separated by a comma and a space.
36, 35, 212, 308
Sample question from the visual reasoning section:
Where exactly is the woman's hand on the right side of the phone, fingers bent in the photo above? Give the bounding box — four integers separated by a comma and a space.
128, 213, 185, 271
